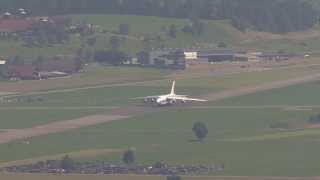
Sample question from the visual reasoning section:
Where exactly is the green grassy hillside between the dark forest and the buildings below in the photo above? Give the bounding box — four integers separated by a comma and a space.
0, 15, 320, 58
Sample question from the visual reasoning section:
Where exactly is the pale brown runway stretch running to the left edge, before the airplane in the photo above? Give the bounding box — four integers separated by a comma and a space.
0, 115, 128, 144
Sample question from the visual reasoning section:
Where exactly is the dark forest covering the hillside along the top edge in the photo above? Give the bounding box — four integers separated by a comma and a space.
0, 0, 320, 33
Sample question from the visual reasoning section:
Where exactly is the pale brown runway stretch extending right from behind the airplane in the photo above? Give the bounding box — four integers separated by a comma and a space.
203, 73, 320, 101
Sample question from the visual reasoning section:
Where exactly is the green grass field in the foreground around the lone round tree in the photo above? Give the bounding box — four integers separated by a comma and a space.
0, 105, 320, 176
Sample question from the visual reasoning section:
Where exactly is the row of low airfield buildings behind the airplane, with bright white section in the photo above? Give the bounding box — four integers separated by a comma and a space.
149, 49, 304, 68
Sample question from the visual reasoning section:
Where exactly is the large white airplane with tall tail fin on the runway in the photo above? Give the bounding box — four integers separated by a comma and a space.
133, 81, 207, 106
